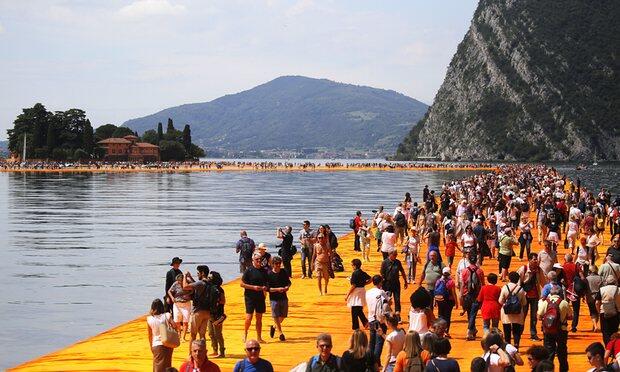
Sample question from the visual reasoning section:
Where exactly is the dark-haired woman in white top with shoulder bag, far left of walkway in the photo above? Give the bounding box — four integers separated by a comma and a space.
146, 298, 174, 372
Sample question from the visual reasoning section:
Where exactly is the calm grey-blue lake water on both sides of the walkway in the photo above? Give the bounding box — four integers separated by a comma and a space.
0, 161, 620, 369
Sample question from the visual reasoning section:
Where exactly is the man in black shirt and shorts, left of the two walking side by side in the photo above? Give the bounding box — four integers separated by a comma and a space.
241, 252, 269, 343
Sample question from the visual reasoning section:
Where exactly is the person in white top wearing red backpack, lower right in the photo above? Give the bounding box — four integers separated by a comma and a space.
537, 287, 571, 372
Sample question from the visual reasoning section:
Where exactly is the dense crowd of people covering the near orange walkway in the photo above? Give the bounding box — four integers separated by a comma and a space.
147, 165, 620, 372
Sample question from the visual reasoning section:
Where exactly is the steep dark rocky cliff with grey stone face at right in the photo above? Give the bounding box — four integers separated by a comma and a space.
396, 0, 620, 160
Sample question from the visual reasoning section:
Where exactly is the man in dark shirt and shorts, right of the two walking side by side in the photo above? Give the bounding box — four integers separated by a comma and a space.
267, 256, 291, 341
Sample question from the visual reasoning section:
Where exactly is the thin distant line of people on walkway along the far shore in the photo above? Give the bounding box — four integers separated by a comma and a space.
0, 159, 493, 171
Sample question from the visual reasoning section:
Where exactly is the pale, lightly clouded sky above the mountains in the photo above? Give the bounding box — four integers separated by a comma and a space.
0, 0, 477, 139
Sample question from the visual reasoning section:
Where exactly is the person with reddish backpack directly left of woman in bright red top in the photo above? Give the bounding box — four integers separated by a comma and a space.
461, 254, 484, 341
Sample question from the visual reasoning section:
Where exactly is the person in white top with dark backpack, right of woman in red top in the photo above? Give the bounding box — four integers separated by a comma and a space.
499, 271, 527, 349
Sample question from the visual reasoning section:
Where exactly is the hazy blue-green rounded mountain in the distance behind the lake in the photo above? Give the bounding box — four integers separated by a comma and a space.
123, 76, 428, 154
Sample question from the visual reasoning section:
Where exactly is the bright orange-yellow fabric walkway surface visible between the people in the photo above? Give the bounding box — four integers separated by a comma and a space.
10, 222, 609, 371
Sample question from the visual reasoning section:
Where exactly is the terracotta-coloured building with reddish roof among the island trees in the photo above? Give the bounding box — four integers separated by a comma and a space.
97, 136, 159, 163
